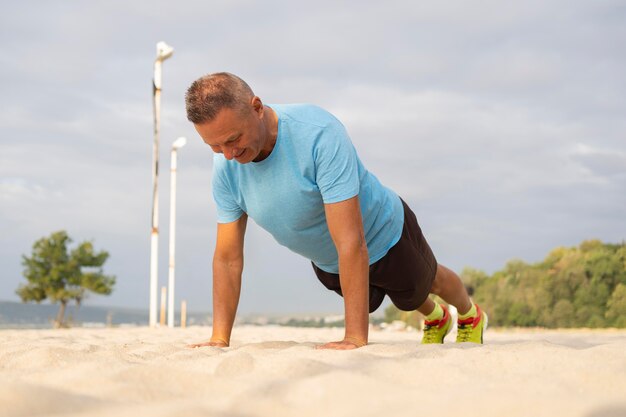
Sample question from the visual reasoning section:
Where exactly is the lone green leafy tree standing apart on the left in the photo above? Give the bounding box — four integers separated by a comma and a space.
15, 230, 115, 327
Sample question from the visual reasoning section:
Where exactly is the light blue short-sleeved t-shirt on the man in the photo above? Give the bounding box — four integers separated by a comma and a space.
213, 104, 404, 274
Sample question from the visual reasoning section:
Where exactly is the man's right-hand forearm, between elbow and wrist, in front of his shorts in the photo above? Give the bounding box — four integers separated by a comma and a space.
339, 246, 369, 346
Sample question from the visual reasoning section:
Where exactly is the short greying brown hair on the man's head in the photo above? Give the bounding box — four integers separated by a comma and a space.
185, 72, 254, 124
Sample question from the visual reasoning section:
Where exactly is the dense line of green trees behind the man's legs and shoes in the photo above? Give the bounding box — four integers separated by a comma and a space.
385, 240, 626, 328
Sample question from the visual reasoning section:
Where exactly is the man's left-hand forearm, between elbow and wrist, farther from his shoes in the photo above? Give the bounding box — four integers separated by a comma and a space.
211, 260, 243, 344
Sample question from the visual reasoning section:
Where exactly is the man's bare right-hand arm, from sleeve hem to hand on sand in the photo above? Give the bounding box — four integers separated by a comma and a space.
320, 196, 369, 349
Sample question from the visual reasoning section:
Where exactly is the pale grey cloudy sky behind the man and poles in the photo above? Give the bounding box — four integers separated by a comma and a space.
0, 0, 626, 314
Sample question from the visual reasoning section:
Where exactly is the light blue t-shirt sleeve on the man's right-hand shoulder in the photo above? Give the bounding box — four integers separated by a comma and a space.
313, 121, 360, 204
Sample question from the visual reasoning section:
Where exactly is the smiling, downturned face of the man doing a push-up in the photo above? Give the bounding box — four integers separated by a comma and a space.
194, 101, 271, 164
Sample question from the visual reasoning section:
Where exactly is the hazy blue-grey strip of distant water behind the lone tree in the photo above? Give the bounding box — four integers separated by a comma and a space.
0, 301, 210, 329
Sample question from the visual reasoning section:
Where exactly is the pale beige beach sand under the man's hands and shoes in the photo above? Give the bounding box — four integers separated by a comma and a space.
0, 326, 626, 417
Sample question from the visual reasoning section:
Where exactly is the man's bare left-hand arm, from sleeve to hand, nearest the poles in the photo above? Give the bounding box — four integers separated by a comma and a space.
190, 213, 248, 347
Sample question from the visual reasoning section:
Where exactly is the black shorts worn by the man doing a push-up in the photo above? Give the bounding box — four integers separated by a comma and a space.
313, 200, 437, 313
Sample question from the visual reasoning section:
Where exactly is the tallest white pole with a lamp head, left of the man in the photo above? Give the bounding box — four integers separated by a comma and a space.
149, 42, 174, 327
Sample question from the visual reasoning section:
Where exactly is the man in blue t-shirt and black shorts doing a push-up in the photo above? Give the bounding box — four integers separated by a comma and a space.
186, 73, 487, 349
